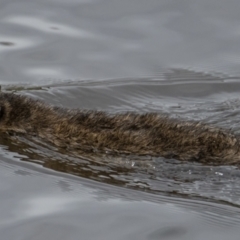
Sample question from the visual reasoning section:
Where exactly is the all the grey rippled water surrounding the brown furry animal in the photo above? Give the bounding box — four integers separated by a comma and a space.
0, 0, 240, 240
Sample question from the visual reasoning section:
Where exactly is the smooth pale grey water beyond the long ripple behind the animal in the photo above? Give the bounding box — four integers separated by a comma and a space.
0, 0, 240, 82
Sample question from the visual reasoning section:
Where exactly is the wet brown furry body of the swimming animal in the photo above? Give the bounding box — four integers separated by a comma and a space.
0, 93, 240, 164
